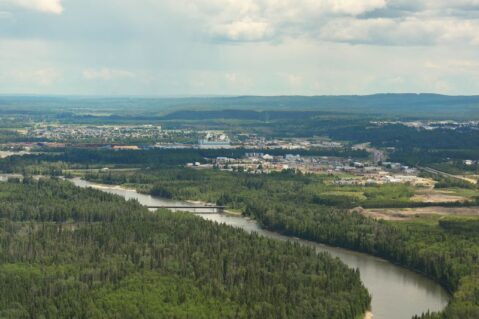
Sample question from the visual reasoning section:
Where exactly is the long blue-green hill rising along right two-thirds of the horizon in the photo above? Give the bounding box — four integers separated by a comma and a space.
156, 94, 479, 119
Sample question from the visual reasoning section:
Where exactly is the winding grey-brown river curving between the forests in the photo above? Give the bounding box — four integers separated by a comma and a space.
71, 178, 450, 319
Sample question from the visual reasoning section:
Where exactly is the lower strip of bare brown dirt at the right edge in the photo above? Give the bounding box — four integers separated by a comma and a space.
354, 207, 479, 221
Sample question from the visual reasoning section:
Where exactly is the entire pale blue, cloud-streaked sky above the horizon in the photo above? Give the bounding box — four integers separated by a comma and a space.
0, 0, 479, 96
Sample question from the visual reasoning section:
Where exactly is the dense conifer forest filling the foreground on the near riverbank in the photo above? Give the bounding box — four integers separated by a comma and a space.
0, 178, 370, 319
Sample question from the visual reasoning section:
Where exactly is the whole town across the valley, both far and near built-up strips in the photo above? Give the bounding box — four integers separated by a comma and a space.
1, 125, 436, 187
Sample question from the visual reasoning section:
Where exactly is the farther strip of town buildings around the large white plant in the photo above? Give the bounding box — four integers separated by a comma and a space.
16, 124, 344, 150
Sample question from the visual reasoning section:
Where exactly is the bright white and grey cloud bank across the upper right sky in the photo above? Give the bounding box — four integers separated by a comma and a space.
160, 0, 479, 45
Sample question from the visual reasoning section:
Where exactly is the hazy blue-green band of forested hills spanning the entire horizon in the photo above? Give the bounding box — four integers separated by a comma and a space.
0, 94, 479, 121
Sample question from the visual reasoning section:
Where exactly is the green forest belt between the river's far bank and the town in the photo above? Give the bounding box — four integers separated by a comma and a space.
89, 169, 479, 319
